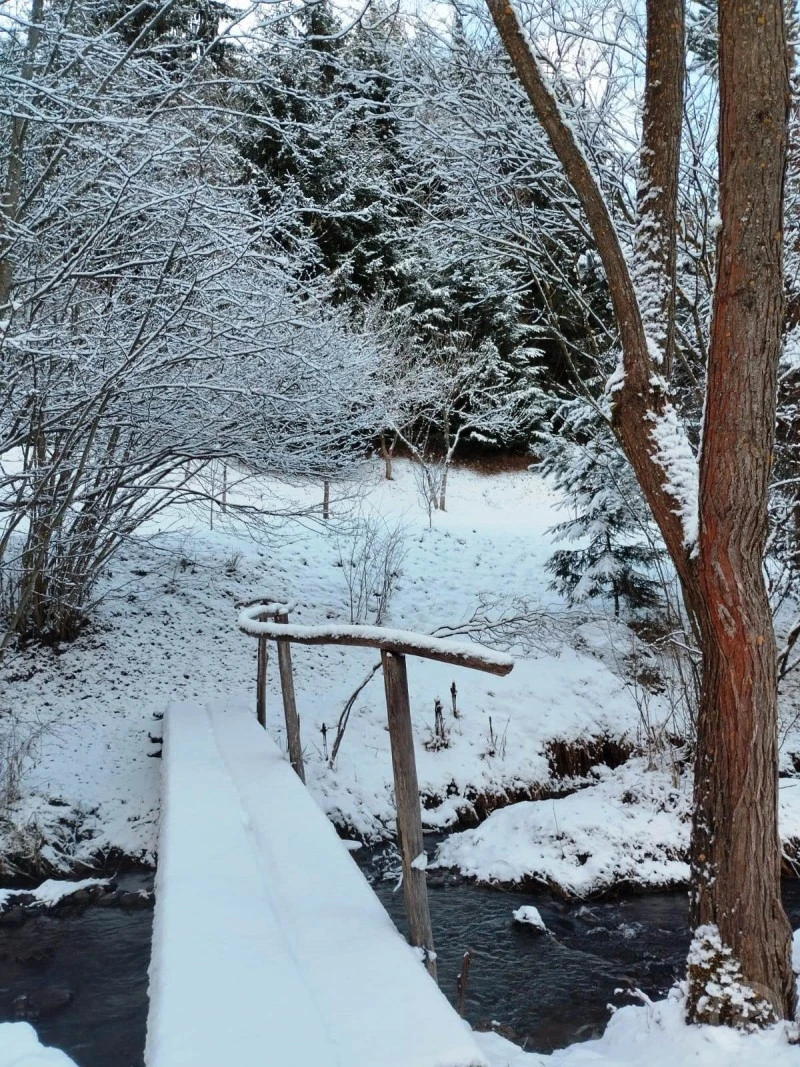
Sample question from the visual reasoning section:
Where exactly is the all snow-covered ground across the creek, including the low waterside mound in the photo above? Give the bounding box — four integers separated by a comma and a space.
1, 462, 800, 893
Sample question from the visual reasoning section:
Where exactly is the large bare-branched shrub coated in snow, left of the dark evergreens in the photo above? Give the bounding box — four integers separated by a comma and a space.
0, 4, 388, 643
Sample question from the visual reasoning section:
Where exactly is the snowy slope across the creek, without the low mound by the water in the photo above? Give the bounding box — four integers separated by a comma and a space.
3, 463, 652, 869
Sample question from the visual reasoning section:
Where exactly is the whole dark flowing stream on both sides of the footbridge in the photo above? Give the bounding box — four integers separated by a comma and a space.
0, 847, 800, 1067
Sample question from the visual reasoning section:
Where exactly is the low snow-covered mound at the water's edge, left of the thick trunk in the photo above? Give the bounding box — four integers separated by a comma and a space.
432, 760, 691, 896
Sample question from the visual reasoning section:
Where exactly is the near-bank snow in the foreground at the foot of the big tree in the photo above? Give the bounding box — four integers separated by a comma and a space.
476, 989, 800, 1067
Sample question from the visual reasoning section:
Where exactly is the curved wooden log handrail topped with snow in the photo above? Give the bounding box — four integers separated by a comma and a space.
239, 604, 514, 674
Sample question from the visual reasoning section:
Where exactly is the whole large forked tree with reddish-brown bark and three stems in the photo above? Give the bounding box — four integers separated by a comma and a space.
486, 0, 795, 1025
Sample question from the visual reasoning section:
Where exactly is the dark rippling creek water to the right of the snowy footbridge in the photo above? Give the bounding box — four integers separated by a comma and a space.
355, 843, 800, 1052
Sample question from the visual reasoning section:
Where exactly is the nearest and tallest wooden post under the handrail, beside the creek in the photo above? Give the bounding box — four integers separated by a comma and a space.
381, 651, 436, 981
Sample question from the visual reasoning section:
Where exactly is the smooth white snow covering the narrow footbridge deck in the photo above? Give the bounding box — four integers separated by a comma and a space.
146, 704, 485, 1067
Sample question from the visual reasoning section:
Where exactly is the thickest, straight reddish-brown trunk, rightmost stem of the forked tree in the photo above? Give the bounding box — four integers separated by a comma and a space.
690, 0, 795, 1019
